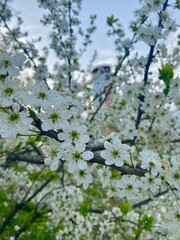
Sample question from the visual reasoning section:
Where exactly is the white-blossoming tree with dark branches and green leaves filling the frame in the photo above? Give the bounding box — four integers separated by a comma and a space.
0, 0, 180, 240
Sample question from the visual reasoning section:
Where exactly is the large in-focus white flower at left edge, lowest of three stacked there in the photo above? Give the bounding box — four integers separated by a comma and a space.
0, 104, 32, 139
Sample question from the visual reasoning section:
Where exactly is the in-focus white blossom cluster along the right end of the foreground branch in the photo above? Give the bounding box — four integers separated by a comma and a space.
100, 133, 180, 199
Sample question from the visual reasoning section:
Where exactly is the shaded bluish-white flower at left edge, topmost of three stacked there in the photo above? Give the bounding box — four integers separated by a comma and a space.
0, 54, 26, 77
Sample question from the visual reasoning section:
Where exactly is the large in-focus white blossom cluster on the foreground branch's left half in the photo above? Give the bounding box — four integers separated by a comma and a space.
0, 51, 94, 188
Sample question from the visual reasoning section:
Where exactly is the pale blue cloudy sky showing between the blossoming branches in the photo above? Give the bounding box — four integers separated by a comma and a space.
11, 0, 179, 67
